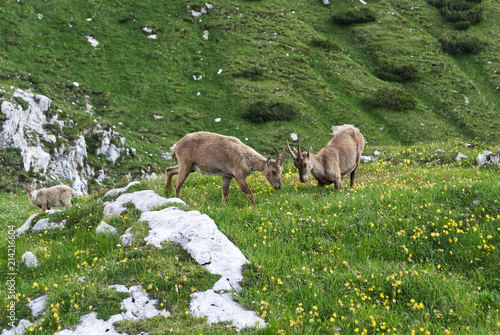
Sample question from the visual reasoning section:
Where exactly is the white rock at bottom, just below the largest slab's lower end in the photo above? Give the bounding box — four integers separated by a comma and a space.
189, 290, 266, 329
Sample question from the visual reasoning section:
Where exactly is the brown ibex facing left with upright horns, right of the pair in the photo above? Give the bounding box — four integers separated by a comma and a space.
287, 125, 366, 190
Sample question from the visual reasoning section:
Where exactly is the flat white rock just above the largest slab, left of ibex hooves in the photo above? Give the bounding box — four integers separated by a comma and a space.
104, 190, 186, 216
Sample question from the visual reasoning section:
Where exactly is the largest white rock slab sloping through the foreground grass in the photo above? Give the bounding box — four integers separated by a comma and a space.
140, 207, 248, 291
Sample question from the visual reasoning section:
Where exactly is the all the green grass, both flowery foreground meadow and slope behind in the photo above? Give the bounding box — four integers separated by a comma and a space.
0, 0, 500, 334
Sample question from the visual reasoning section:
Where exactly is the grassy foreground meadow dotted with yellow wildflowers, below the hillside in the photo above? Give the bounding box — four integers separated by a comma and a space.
0, 141, 500, 334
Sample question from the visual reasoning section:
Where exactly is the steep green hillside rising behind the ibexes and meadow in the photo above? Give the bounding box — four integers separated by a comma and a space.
0, 0, 500, 169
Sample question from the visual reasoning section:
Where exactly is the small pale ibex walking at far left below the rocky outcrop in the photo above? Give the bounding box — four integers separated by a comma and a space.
26, 185, 76, 212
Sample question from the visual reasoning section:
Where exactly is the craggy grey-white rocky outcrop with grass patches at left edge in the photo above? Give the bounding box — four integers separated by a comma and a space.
0, 89, 134, 194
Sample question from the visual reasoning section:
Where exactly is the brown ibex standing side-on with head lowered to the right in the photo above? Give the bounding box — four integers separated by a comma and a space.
165, 132, 285, 205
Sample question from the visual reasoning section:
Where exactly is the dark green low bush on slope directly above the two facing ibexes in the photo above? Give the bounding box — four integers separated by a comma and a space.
242, 101, 297, 123
